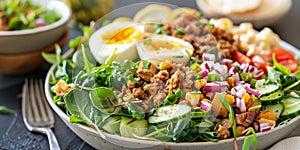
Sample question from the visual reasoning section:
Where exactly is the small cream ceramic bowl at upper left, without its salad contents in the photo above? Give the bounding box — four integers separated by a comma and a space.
0, 0, 72, 54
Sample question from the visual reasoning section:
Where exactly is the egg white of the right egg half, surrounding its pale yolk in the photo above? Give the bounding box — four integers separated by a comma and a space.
137, 35, 194, 65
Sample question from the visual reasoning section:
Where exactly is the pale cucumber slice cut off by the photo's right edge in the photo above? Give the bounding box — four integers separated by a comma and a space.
281, 97, 300, 119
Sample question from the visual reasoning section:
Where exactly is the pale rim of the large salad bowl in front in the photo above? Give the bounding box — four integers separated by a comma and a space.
44, 41, 300, 147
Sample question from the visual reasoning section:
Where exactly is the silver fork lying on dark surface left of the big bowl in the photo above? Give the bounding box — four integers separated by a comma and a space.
22, 79, 60, 150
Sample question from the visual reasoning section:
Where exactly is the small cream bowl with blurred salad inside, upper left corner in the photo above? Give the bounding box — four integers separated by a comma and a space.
0, 0, 71, 55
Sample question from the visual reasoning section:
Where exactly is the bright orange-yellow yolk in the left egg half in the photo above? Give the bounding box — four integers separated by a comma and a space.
102, 27, 142, 44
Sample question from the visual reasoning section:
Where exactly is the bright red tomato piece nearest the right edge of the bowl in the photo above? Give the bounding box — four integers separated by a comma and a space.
268, 48, 298, 73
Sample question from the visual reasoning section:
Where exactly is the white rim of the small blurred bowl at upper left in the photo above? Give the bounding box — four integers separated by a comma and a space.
0, 0, 72, 37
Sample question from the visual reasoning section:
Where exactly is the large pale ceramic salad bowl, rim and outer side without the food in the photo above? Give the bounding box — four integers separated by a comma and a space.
45, 42, 300, 150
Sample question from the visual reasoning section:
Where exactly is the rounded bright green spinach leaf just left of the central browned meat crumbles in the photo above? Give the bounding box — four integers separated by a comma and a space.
89, 87, 122, 115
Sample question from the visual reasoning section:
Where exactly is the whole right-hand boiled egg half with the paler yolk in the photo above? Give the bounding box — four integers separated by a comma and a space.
137, 35, 193, 65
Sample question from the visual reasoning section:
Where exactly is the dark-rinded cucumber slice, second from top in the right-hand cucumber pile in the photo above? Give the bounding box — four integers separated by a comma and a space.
259, 90, 284, 105
